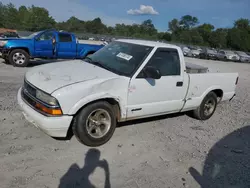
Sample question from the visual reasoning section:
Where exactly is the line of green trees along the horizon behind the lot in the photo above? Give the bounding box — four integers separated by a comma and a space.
0, 2, 250, 51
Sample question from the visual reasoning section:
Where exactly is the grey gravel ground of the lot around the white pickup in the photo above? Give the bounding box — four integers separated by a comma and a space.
0, 58, 250, 188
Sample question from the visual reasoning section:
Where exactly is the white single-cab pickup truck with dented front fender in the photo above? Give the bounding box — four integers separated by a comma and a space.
18, 40, 238, 146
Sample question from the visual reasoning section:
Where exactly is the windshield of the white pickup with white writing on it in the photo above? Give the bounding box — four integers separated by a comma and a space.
85, 41, 153, 77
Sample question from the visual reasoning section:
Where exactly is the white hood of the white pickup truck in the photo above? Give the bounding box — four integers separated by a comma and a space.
25, 60, 119, 94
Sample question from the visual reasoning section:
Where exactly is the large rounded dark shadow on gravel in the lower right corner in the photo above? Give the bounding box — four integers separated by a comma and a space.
189, 126, 250, 188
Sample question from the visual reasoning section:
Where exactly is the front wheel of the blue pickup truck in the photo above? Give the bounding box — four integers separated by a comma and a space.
9, 49, 30, 67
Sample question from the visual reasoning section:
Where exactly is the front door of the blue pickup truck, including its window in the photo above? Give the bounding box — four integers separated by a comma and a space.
34, 31, 54, 57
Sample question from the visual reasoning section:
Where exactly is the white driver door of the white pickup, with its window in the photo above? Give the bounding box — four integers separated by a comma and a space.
127, 48, 188, 118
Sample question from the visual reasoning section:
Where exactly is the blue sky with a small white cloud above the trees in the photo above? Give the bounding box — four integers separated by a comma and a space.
0, 0, 250, 31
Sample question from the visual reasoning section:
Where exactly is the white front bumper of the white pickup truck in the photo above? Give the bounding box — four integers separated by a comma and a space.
17, 88, 73, 137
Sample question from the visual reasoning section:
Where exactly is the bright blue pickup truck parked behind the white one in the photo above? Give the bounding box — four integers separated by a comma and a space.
0, 29, 104, 67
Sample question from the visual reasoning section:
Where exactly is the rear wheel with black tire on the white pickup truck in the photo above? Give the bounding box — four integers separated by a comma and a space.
193, 92, 218, 120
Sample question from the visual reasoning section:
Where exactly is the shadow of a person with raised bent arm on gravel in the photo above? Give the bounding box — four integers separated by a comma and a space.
58, 149, 111, 188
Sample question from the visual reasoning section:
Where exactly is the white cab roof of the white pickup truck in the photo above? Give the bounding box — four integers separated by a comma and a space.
116, 39, 179, 48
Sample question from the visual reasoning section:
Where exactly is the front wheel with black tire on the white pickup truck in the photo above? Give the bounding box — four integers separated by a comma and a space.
72, 101, 117, 147
